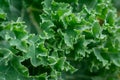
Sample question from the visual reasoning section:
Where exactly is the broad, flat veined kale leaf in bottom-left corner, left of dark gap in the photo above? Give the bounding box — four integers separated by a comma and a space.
0, 63, 34, 80
